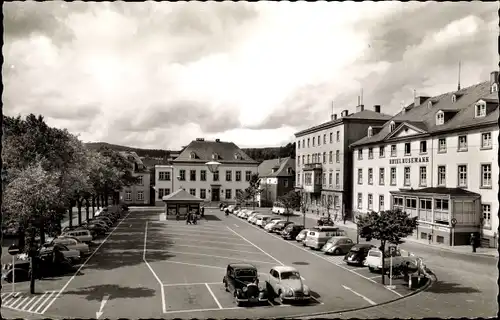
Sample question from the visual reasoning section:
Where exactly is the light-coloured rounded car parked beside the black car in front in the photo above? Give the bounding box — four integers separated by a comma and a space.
266, 266, 311, 303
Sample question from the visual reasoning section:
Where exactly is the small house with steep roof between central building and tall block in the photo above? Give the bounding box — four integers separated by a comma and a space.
257, 157, 295, 207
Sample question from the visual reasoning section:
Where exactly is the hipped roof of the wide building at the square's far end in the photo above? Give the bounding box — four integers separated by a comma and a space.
172, 140, 258, 164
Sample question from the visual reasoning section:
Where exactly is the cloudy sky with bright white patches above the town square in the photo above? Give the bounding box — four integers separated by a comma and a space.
2, 1, 499, 149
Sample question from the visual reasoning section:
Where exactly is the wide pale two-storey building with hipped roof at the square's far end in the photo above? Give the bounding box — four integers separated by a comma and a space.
155, 138, 259, 205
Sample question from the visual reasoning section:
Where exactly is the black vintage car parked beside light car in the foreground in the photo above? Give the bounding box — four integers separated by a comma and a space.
222, 263, 268, 306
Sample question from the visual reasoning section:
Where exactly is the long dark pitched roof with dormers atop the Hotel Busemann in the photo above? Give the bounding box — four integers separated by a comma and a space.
351, 81, 499, 147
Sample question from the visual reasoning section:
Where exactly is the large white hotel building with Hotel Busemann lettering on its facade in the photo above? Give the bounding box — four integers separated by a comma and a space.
351, 72, 499, 246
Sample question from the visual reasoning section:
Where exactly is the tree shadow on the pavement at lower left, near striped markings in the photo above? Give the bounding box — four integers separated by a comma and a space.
65, 284, 156, 301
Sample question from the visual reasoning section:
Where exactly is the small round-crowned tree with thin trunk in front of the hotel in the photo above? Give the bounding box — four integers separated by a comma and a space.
357, 209, 418, 284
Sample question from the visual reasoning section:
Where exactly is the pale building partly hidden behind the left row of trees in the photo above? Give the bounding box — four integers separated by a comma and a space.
120, 151, 151, 205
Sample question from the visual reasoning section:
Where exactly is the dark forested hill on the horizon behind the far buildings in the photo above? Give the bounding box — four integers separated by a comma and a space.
86, 142, 295, 162
